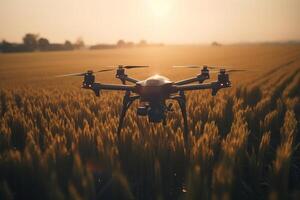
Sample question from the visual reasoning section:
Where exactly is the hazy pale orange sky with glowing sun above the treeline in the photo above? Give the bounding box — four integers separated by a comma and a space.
0, 0, 300, 44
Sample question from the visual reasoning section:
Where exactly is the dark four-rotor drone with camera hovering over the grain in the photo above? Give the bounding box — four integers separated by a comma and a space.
56, 65, 244, 143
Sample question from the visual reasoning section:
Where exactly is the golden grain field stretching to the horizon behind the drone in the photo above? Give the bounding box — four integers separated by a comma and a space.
0, 44, 300, 199
